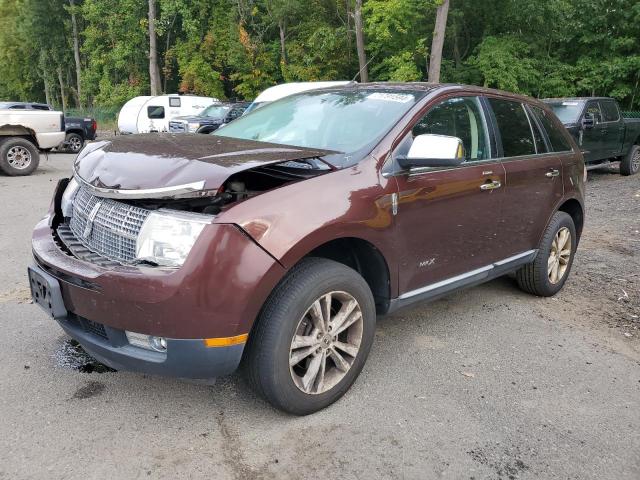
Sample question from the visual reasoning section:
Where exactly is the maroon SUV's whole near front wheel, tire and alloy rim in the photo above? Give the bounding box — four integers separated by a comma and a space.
245, 258, 376, 415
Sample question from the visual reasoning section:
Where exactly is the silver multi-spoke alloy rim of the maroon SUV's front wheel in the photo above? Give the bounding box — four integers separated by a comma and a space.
289, 292, 364, 395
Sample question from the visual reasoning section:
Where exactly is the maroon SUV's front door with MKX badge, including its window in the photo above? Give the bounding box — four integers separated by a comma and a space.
394, 97, 505, 295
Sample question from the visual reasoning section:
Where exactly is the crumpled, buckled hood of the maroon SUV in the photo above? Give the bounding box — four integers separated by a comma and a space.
74, 133, 335, 198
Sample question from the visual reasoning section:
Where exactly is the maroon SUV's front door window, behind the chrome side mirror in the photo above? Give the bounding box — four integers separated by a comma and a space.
413, 97, 491, 161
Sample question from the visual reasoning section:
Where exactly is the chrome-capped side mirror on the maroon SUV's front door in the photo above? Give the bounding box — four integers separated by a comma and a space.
398, 133, 464, 169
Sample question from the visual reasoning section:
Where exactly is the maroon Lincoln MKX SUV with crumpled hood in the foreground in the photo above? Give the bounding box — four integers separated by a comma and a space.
29, 83, 584, 414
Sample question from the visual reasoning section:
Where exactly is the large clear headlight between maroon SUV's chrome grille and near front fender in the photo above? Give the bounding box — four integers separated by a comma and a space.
136, 210, 214, 267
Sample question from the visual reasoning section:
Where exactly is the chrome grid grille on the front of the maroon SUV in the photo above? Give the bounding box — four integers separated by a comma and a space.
69, 187, 149, 264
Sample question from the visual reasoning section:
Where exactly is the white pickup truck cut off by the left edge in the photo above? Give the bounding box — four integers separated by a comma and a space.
0, 109, 65, 176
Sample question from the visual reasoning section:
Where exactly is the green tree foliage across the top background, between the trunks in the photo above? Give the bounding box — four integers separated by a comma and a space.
0, 0, 640, 109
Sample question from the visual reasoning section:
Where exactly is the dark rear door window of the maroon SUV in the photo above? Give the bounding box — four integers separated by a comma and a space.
488, 98, 536, 157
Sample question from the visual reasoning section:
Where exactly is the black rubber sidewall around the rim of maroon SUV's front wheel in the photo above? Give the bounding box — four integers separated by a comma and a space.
255, 259, 376, 415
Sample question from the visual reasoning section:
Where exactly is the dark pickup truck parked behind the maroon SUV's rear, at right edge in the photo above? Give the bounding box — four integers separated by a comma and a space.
543, 97, 640, 175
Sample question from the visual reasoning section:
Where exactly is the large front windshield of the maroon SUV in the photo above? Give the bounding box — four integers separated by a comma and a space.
215, 89, 424, 158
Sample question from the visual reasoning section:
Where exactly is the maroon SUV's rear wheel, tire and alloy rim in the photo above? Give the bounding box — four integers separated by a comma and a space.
516, 212, 577, 297
